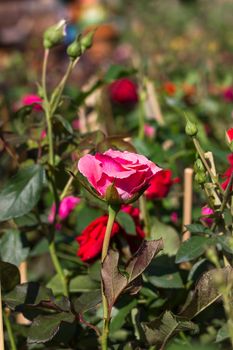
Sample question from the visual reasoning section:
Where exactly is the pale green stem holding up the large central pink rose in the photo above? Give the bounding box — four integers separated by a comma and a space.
101, 205, 118, 350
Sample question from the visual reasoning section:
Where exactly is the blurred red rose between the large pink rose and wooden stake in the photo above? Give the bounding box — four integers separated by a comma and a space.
145, 169, 180, 199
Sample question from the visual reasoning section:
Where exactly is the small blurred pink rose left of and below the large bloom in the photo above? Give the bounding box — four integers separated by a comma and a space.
48, 196, 80, 229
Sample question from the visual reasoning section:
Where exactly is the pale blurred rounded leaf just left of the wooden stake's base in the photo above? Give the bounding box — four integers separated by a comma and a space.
151, 219, 180, 256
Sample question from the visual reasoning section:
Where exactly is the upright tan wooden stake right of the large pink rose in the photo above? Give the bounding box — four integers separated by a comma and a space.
182, 168, 193, 241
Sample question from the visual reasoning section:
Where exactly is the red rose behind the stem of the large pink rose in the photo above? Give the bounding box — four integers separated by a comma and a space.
76, 205, 145, 261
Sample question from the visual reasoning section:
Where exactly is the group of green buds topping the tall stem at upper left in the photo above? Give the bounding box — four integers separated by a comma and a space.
44, 19, 95, 60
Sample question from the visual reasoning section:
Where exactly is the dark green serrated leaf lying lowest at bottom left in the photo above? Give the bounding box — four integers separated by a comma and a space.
27, 312, 75, 343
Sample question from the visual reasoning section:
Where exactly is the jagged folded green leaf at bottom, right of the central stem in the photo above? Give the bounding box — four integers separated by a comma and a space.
142, 311, 197, 349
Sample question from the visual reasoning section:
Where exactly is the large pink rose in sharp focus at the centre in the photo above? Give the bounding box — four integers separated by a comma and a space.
78, 149, 161, 201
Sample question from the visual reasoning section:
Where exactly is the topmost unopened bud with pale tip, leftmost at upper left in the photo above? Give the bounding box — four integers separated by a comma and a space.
44, 19, 66, 49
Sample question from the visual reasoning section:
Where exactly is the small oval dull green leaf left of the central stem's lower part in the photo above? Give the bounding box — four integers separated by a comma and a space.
73, 289, 102, 313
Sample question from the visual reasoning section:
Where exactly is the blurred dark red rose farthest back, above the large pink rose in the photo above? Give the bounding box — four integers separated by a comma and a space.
109, 78, 138, 105
